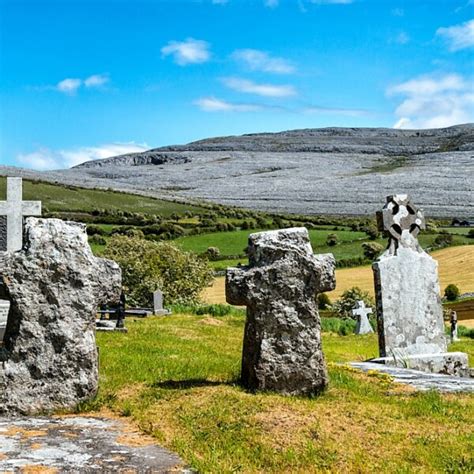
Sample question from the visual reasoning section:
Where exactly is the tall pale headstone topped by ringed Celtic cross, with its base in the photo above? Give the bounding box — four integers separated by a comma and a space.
373, 194, 468, 375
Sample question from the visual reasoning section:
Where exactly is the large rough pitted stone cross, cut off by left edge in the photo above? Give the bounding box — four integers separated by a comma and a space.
0, 218, 121, 414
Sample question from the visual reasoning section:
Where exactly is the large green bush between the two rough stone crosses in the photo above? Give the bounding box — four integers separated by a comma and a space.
104, 235, 212, 306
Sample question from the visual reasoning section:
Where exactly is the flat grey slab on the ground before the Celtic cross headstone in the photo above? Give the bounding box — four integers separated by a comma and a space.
350, 362, 474, 393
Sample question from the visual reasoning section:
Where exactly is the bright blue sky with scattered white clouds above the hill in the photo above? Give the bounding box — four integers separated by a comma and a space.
0, 0, 474, 169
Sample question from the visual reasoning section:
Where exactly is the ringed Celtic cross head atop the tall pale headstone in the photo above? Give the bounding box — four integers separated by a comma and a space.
382, 194, 425, 240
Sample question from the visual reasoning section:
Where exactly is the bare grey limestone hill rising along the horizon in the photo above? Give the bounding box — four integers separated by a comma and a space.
0, 124, 474, 218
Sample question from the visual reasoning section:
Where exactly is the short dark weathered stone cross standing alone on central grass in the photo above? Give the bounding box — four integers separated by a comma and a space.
226, 228, 335, 395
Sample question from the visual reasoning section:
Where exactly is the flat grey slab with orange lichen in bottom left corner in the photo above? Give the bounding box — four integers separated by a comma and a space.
0, 416, 185, 474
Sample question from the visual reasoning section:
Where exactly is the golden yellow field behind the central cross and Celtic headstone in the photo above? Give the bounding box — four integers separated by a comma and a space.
203, 245, 474, 303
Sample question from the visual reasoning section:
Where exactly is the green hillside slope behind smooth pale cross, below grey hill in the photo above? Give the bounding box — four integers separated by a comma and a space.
0, 177, 202, 216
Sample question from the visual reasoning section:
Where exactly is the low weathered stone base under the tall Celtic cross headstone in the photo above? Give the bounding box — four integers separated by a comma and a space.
370, 352, 470, 377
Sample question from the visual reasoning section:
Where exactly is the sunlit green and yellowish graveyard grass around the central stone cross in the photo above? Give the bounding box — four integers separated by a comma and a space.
93, 315, 474, 473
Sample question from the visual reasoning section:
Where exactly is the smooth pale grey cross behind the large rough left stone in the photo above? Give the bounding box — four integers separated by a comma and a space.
0, 178, 41, 252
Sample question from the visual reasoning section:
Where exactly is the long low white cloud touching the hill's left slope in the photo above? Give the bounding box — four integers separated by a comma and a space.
16, 142, 150, 170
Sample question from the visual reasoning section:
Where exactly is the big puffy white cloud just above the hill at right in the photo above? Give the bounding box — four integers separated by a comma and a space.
387, 74, 474, 128
